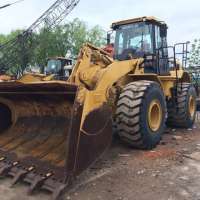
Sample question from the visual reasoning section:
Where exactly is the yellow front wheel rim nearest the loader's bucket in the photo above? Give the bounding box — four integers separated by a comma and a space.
148, 100, 162, 132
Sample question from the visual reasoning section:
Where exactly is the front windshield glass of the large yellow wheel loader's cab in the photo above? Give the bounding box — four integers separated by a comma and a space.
115, 22, 153, 59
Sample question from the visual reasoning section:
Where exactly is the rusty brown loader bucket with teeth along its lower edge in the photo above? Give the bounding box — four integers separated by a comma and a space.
0, 81, 112, 199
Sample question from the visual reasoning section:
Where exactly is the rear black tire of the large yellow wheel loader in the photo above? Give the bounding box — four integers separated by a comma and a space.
167, 83, 196, 128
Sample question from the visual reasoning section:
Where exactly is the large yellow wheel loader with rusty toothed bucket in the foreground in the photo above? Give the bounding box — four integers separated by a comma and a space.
0, 17, 196, 199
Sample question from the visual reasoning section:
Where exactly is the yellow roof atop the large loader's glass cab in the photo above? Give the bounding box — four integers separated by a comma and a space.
111, 16, 165, 29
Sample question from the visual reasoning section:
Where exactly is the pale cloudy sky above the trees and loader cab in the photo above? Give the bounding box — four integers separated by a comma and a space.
0, 0, 200, 44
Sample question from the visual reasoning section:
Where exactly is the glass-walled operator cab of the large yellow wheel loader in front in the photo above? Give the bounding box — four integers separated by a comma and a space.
108, 17, 169, 75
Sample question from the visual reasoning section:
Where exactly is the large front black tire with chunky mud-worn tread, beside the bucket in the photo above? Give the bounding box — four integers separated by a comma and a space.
115, 81, 166, 149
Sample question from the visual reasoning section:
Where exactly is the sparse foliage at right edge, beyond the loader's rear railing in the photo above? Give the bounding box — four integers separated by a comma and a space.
189, 39, 200, 67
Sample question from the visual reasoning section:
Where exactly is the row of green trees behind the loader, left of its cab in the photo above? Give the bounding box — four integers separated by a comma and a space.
0, 19, 105, 74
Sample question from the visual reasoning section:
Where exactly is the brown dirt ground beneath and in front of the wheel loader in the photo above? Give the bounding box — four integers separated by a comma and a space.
0, 116, 200, 200
